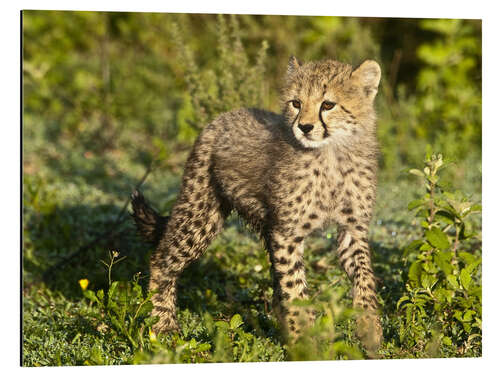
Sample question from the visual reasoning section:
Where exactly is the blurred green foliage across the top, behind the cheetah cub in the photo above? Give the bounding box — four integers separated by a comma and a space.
23, 11, 481, 170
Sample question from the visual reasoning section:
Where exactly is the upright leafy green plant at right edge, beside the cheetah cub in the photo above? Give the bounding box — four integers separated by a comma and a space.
397, 154, 482, 355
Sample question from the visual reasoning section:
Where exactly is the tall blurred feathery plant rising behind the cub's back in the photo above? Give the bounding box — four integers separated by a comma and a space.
172, 15, 268, 140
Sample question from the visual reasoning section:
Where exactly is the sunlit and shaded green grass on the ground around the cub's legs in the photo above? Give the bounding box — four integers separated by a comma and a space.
23, 133, 481, 366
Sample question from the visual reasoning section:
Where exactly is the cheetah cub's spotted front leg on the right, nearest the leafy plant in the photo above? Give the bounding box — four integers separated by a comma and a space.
337, 225, 383, 353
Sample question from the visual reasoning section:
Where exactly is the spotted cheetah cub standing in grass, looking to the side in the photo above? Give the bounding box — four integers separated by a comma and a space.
132, 56, 382, 350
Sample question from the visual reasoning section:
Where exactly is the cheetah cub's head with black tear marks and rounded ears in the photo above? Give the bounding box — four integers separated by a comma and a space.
282, 56, 380, 148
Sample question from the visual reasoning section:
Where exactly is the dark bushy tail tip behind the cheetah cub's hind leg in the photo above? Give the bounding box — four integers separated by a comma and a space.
130, 190, 169, 246
